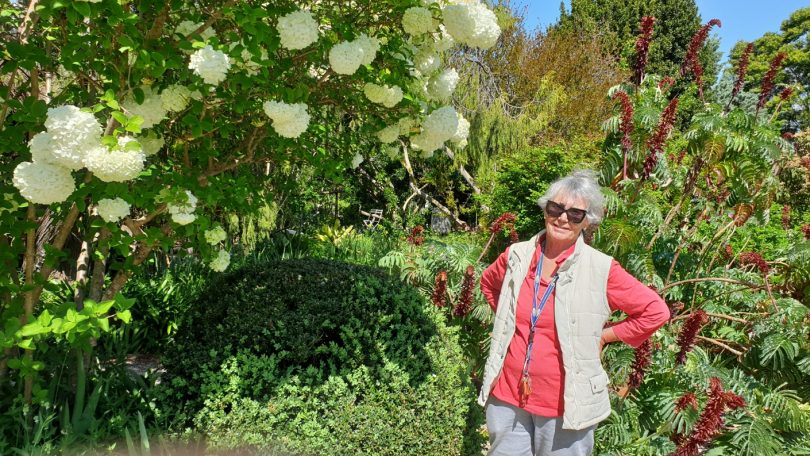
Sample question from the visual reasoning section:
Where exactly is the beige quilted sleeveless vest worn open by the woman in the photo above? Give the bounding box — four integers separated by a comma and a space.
478, 231, 612, 429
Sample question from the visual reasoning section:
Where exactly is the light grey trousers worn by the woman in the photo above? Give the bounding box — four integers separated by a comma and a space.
486, 395, 596, 456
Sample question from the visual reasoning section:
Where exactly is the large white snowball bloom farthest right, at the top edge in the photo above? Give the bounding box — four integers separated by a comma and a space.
442, 3, 501, 49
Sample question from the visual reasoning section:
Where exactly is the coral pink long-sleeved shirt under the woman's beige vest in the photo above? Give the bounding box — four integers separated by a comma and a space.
481, 239, 669, 417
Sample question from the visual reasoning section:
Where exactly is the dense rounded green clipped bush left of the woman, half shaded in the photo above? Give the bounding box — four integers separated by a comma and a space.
163, 259, 482, 455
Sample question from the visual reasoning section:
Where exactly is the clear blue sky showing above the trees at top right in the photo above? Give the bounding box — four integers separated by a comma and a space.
515, 0, 810, 61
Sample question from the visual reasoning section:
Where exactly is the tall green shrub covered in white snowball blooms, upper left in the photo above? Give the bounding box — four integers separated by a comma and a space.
0, 0, 500, 412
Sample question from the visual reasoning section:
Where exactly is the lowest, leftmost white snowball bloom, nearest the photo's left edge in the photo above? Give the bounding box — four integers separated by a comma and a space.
11, 162, 76, 204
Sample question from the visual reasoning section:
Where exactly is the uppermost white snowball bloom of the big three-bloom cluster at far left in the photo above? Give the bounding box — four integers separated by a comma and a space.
42, 105, 102, 169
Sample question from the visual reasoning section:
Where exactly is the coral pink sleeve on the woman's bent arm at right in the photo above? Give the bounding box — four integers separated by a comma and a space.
607, 260, 669, 347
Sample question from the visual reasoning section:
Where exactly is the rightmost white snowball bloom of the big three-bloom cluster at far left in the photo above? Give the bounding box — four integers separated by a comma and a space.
84, 136, 145, 182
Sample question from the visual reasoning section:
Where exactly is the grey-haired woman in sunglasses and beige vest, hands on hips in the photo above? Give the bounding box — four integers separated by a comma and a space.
478, 171, 669, 456
